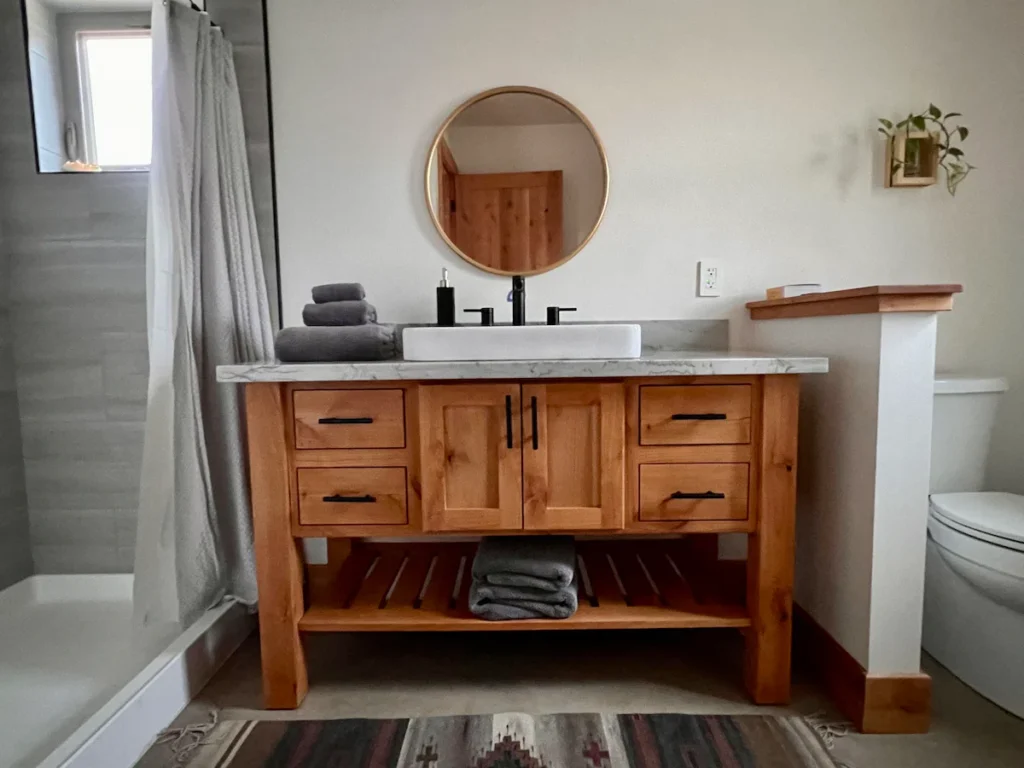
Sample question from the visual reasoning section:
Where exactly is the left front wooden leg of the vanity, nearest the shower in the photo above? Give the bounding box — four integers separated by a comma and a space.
246, 383, 308, 710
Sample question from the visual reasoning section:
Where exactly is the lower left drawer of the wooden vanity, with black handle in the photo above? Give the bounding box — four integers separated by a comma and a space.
298, 467, 409, 525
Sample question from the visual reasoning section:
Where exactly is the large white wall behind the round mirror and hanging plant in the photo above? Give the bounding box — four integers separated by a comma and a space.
268, 0, 1024, 490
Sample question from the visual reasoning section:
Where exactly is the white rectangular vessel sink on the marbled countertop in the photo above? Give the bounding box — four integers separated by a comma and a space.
401, 323, 640, 360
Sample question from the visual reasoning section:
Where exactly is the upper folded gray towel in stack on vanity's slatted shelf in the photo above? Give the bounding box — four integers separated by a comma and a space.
473, 536, 575, 592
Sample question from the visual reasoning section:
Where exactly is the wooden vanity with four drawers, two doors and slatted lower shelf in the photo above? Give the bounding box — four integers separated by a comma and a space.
228, 358, 826, 709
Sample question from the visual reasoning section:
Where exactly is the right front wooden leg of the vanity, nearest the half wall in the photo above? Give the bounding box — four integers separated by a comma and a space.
745, 375, 800, 705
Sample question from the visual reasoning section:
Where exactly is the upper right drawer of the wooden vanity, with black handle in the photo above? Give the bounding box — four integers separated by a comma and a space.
640, 384, 751, 445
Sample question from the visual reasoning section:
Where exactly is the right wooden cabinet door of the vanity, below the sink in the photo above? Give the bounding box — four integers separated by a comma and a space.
522, 384, 626, 530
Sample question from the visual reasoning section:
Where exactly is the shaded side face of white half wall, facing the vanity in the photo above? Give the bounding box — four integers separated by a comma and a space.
751, 314, 880, 672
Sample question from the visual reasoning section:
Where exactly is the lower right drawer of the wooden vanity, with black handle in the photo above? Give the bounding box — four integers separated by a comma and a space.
640, 464, 750, 521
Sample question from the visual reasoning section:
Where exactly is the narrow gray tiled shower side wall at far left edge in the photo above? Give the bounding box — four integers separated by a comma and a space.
0, 217, 32, 590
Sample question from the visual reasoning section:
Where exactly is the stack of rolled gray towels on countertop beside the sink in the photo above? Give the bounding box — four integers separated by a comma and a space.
273, 283, 396, 362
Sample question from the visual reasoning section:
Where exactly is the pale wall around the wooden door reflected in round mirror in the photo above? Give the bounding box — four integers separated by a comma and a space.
446, 123, 604, 254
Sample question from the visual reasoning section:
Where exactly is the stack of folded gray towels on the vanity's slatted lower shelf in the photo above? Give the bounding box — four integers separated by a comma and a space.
469, 536, 579, 622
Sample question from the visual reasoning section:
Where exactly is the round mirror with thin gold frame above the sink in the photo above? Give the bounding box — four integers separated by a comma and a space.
426, 86, 608, 274
